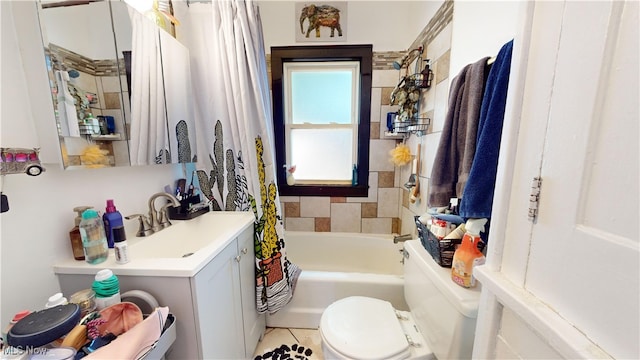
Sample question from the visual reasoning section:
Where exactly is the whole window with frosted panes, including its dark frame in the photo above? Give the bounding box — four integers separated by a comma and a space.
271, 45, 372, 196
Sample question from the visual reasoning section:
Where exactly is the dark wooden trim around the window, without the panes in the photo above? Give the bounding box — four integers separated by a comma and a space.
271, 45, 373, 197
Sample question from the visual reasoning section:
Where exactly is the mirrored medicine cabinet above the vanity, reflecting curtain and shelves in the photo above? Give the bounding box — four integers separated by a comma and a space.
38, 0, 196, 169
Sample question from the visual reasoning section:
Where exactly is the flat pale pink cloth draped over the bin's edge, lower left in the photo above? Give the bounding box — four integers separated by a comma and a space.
84, 306, 169, 360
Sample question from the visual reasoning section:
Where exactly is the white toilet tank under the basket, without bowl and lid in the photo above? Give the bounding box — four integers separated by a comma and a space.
404, 240, 480, 360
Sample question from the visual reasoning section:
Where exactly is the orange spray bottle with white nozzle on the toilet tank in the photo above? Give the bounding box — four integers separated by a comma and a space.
451, 219, 487, 288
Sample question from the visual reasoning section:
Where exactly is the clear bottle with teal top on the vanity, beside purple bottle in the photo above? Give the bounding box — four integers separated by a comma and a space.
79, 209, 109, 264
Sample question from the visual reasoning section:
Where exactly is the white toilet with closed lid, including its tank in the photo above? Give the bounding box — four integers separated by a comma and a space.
319, 240, 480, 360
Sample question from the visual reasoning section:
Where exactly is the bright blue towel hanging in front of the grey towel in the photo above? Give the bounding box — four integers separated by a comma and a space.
460, 40, 513, 218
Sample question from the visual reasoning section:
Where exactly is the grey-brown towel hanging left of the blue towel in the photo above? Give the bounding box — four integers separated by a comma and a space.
428, 57, 489, 207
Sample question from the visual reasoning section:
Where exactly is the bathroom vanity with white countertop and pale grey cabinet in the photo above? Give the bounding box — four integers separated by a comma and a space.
54, 212, 265, 359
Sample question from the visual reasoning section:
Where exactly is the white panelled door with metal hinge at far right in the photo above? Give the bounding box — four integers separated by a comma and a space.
474, 1, 640, 359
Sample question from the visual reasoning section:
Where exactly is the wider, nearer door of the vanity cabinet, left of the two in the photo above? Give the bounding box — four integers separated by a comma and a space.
192, 240, 245, 359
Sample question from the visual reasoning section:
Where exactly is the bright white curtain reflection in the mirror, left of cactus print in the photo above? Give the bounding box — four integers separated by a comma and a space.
129, 8, 169, 165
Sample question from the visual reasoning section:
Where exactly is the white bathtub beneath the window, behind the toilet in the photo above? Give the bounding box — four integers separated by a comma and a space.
267, 231, 408, 329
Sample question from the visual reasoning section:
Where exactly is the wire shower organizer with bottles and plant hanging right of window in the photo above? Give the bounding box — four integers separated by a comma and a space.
386, 47, 433, 140
